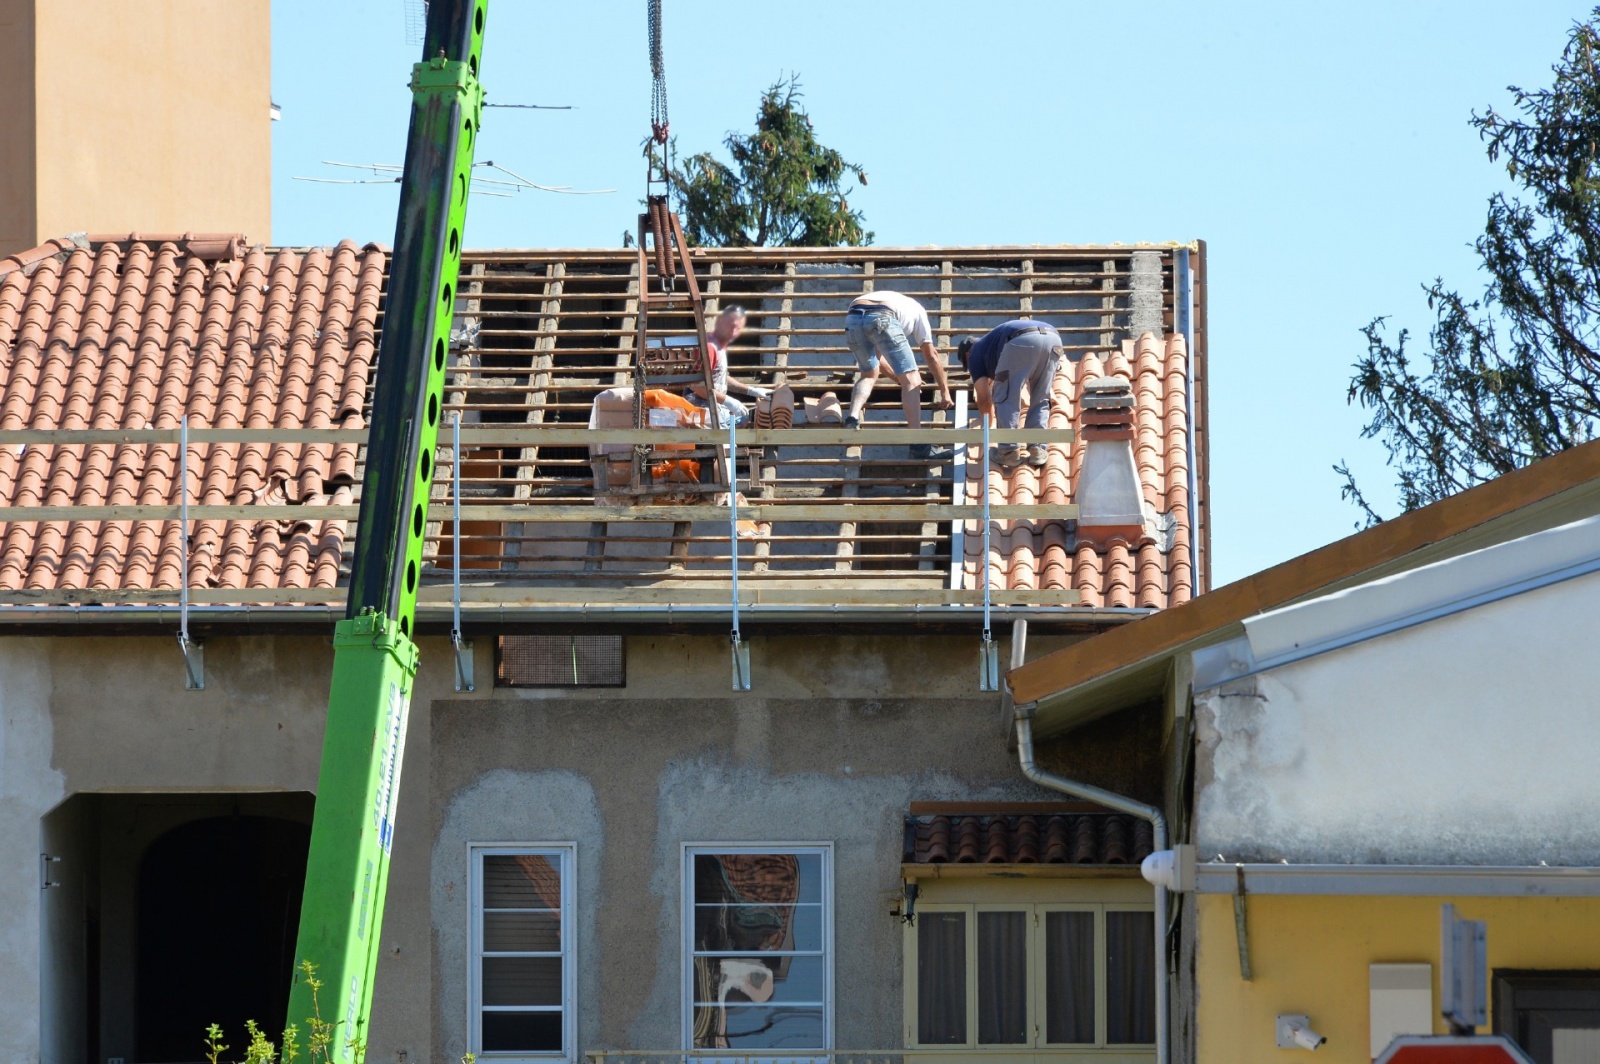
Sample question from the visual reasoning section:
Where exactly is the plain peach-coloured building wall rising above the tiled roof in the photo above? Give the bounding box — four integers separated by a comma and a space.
0, 0, 272, 254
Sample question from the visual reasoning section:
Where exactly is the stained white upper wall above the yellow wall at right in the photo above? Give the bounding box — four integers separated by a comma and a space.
1195, 563, 1600, 866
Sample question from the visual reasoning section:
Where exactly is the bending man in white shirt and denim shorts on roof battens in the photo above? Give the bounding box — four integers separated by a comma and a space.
845, 291, 955, 461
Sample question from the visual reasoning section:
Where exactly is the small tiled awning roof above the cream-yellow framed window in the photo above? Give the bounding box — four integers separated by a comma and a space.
902, 813, 1154, 866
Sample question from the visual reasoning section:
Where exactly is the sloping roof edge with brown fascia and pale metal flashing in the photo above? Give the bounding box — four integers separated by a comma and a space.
1006, 440, 1600, 726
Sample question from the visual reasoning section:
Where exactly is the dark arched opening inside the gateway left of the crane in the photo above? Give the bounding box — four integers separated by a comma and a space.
136, 816, 310, 1064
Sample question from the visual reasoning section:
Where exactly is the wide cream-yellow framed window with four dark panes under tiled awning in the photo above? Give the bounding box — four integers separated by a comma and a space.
906, 902, 1155, 1050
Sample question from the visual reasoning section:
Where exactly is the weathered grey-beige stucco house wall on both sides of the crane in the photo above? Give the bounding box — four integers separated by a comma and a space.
0, 634, 1144, 1061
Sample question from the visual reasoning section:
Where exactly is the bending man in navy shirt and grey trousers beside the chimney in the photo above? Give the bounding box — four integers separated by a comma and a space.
957, 318, 1066, 469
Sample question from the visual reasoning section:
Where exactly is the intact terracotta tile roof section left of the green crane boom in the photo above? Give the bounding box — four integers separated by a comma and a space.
0, 234, 384, 590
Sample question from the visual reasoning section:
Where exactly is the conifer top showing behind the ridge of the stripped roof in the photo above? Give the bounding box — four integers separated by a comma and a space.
659, 77, 872, 248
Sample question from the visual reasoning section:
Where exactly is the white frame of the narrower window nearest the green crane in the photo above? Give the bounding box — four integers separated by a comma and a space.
467, 842, 578, 1062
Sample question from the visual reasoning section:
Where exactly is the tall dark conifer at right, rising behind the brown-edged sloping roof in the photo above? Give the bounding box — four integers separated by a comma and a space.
1334, 8, 1600, 525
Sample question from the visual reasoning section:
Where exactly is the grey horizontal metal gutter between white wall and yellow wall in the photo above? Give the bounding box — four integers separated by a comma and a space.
1195, 862, 1600, 898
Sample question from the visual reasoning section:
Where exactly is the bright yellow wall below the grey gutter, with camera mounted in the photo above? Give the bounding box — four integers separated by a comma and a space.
1195, 894, 1600, 1064
